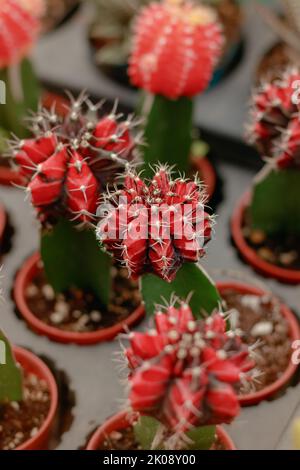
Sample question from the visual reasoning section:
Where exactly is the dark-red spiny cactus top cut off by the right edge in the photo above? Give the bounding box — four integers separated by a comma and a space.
247, 69, 300, 169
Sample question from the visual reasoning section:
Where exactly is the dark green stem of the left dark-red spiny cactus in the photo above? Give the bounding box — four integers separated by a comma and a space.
41, 219, 111, 307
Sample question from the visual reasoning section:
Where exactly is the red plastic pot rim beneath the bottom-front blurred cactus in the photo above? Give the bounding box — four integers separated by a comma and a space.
86, 411, 236, 450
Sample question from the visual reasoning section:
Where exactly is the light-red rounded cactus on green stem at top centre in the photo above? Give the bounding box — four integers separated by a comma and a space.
128, 0, 223, 173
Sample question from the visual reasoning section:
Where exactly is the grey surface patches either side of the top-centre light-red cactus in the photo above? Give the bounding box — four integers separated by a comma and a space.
35, 0, 274, 141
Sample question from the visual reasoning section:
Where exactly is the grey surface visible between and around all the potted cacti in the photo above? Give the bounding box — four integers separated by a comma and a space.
0, 1, 300, 449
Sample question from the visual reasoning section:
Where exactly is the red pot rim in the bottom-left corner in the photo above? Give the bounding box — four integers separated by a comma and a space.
13, 347, 58, 450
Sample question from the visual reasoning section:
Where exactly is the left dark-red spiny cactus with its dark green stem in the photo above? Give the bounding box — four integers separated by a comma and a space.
11, 93, 139, 305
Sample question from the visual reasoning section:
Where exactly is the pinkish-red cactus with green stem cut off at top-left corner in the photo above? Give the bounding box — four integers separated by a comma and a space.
0, 0, 44, 145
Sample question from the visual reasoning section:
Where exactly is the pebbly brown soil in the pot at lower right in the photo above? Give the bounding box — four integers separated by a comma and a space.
222, 289, 292, 395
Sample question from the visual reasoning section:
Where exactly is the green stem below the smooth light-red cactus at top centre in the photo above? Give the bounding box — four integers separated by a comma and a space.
144, 95, 193, 177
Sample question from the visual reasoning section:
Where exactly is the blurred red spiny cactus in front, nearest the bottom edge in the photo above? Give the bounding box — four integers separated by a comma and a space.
119, 298, 257, 450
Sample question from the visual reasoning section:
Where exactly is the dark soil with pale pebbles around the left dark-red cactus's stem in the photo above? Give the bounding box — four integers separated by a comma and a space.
25, 265, 141, 333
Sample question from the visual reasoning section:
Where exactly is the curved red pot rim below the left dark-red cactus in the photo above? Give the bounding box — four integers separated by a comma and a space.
14, 253, 145, 345
